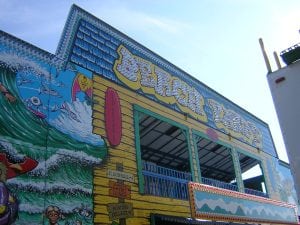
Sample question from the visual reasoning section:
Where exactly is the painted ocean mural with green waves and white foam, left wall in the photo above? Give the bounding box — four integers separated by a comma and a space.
0, 50, 107, 224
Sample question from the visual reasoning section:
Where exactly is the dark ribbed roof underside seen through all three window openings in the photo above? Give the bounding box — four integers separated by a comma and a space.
139, 113, 257, 182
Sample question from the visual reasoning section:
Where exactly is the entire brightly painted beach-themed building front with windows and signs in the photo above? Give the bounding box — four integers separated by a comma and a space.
0, 5, 298, 225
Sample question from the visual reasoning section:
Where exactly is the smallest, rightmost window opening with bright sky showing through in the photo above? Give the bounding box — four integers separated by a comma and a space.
239, 153, 268, 197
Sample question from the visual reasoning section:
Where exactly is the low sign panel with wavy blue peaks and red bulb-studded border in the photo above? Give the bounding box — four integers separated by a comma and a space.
189, 183, 298, 224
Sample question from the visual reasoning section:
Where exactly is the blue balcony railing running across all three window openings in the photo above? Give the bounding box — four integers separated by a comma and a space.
142, 161, 268, 200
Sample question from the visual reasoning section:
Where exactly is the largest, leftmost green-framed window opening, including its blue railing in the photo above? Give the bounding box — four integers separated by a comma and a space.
136, 112, 192, 199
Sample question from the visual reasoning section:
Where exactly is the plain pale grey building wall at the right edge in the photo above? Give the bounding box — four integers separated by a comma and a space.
267, 44, 300, 202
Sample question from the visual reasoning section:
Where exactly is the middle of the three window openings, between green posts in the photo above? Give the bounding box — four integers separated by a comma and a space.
195, 135, 238, 191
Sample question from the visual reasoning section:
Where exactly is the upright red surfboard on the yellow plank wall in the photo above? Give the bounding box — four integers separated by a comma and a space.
104, 88, 122, 146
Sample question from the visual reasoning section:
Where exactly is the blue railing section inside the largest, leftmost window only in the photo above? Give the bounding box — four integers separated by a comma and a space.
143, 162, 192, 200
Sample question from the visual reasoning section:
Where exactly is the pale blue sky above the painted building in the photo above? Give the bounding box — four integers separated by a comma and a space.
0, 0, 300, 161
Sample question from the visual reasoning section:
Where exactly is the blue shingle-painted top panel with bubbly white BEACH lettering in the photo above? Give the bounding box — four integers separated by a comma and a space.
56, 7, 277, 157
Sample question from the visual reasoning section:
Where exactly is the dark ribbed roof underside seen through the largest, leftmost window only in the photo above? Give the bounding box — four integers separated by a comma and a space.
140, 114, 190, 171
